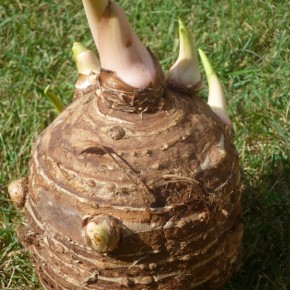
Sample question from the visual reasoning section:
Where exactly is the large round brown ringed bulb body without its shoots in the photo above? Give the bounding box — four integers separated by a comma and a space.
19, 58, 243, 290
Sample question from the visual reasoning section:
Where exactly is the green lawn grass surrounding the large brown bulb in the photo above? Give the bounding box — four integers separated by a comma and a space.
0, 0, 290, 290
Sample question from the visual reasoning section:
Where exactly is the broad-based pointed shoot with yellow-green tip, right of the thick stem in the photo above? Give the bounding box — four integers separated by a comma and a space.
168, 19, 201, 88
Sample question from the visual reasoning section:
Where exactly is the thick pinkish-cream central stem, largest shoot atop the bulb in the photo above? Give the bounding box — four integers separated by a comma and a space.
83, 0, 156, 88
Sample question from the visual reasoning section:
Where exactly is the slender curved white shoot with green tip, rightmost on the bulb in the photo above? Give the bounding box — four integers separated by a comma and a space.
199, 49, 232, 127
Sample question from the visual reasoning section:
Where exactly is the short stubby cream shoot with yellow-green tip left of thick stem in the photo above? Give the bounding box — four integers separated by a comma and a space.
72, 42, 101, 76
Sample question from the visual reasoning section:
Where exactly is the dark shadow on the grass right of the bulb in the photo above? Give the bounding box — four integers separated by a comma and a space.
223, 157, 290, 290
